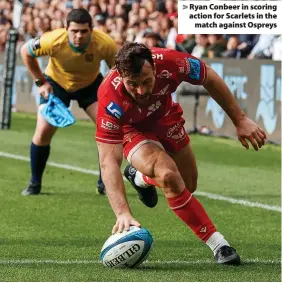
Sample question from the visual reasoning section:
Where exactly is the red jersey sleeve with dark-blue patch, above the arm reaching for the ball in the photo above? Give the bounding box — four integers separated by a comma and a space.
96, 87, 123, 144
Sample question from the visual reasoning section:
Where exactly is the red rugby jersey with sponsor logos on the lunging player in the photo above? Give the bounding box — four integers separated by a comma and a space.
96, 48, 206, 143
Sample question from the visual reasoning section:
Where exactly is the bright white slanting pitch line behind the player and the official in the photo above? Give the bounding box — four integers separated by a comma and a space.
0, 151, 282, 213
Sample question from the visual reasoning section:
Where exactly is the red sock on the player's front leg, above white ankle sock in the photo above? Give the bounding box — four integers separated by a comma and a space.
167, 188, 216, 242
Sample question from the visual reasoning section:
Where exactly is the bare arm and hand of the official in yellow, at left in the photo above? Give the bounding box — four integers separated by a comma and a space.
20, 42, 53, 98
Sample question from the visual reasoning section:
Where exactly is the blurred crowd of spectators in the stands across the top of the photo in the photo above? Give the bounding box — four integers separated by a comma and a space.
0, 0, 282, 60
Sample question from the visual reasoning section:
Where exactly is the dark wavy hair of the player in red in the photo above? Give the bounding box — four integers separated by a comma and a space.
115, 42, 154, 77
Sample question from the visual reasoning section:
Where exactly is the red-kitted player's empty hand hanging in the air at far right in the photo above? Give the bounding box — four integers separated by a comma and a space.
236, 117, 266, 150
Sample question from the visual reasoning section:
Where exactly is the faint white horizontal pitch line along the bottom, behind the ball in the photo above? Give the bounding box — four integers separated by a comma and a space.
0, 258, 281, 265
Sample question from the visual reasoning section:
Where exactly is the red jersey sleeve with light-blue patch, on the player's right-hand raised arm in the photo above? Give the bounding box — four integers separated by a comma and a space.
173, 52, 207, 85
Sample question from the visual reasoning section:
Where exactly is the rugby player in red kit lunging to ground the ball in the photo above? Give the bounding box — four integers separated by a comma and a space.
96, 43, 266, 264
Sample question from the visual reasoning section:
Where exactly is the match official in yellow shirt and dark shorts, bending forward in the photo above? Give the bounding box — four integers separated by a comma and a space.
21, 9, 117, 196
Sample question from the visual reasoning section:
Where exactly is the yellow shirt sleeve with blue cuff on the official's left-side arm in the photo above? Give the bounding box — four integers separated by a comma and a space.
27, 32, 54, 57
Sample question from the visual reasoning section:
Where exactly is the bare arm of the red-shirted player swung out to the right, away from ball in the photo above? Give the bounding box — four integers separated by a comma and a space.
203, 66, 266, 150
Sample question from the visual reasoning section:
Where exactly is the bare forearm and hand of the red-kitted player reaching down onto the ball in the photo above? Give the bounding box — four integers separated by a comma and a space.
97, 142, 140, 233
